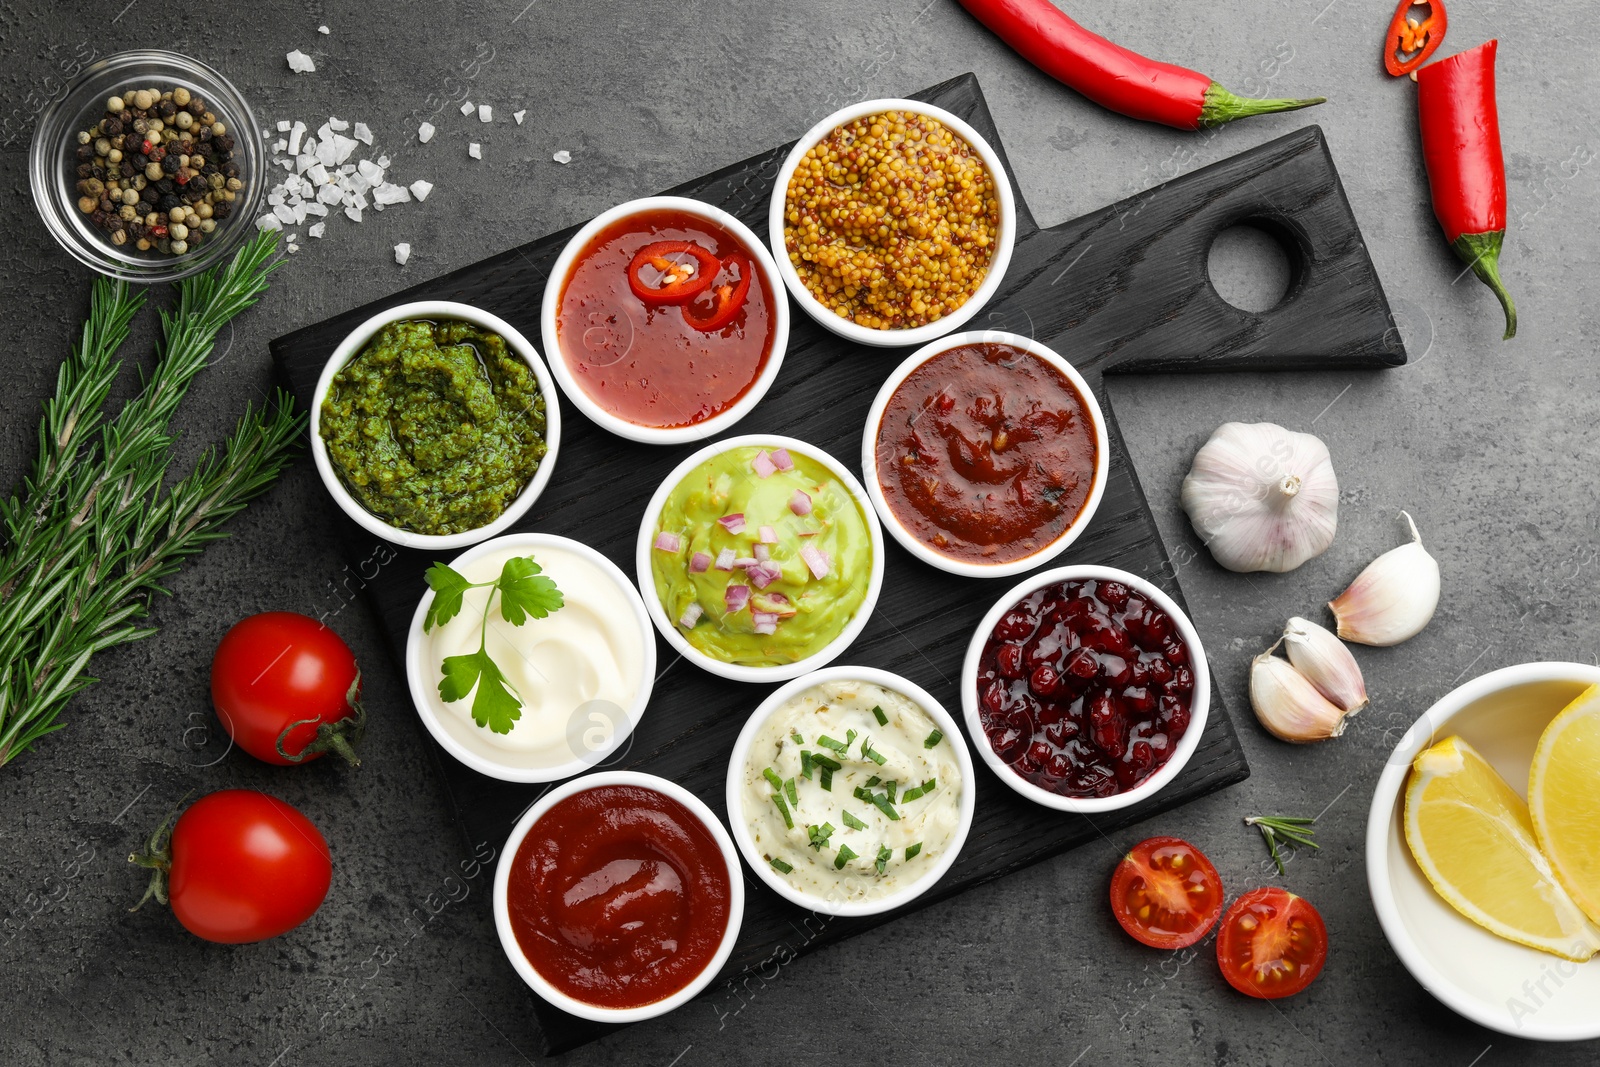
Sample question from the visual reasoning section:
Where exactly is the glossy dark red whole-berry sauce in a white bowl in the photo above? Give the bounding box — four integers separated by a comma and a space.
978, 581, 1195, 797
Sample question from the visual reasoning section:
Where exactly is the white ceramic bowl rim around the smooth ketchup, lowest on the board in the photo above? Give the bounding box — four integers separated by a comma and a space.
494, 771, 744, 1024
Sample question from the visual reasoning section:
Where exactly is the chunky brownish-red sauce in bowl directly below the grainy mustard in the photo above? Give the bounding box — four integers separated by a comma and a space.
877, 344, 1098, 563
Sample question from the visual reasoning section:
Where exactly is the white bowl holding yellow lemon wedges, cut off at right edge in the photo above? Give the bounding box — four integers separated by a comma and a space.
1366, 662, 1600, 1041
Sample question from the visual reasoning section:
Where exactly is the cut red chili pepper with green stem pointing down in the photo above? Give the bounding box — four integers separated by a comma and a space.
1416, 40, 1517, 341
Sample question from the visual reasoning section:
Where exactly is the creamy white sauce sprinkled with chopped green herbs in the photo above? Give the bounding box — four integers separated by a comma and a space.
742, 680, 970, 904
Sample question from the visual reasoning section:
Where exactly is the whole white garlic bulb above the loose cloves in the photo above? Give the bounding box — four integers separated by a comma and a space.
1182, 422, 1339, 571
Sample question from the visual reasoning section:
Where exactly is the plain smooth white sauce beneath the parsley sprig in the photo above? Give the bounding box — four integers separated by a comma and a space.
422, 545, 650, 769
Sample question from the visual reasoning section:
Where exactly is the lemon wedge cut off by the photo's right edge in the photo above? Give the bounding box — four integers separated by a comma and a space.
1528, 685, 1600, 923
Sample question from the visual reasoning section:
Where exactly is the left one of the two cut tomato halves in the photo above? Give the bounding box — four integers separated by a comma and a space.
1110, 837, 1222, 949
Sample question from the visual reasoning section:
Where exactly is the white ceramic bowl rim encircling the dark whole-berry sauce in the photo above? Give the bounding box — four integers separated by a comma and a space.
962, 566, 1211, 814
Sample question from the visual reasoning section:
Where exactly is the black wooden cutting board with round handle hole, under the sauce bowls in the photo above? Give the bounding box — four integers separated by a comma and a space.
272, 75, 1405, 1053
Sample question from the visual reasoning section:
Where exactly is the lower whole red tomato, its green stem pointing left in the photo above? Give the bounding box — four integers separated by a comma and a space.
133, 789, 333, 945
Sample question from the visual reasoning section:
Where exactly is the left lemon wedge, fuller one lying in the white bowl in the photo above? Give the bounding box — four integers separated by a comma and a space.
1405, 737, 1600, 963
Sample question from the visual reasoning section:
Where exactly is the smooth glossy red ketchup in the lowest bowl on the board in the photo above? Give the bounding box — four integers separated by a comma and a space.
507, 785, 731, 1008
